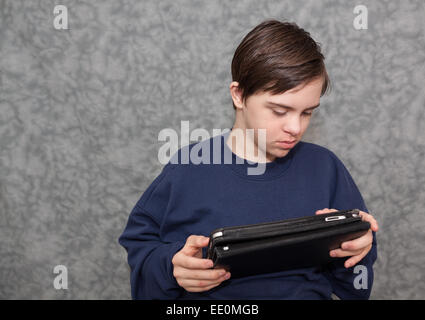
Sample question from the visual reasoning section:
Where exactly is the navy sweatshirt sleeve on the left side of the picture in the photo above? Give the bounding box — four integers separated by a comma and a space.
119, 165, 185, 299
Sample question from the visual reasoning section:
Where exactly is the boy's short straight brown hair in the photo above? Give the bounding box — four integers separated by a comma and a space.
232, 20, 330, 110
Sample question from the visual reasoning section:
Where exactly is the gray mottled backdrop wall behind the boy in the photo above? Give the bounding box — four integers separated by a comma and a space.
0, 0, 425, 299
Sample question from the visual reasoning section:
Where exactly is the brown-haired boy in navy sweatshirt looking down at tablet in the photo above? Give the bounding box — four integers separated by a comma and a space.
119, 20, 378, 299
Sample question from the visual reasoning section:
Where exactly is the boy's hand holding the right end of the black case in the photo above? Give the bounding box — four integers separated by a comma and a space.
316, 208, 379, 268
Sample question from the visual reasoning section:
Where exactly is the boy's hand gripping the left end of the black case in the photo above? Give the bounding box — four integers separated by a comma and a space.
171, 235, 230, 292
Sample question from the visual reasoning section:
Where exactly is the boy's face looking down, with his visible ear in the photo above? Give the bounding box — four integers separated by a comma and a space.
230, 78, 323, 161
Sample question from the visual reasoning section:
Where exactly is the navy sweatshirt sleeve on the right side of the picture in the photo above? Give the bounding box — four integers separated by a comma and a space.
325, 151, 377, 299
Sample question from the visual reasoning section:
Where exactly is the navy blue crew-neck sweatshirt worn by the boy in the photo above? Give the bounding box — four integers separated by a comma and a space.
119, 131, 377, 299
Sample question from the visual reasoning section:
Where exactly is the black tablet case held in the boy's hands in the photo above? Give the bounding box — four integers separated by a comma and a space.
207, 209, 370, 278
